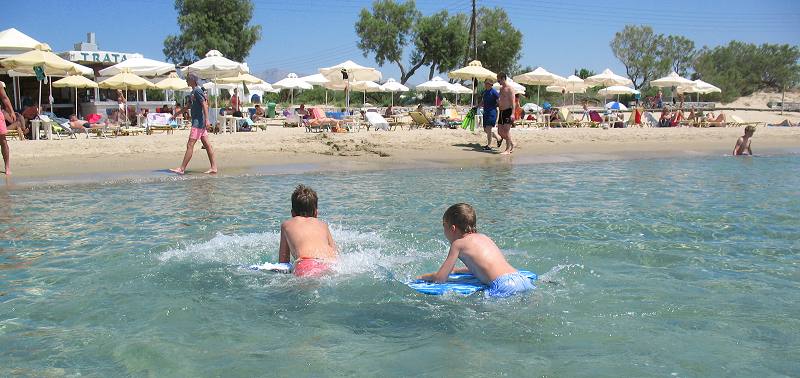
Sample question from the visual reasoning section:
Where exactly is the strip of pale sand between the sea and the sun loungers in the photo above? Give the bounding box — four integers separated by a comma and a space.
5, 127, 800, 187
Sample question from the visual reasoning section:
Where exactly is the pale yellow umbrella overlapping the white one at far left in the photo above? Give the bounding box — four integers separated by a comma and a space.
0, 43, 87, 110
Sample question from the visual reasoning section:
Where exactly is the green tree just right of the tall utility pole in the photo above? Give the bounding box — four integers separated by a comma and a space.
476, 7, 522, 72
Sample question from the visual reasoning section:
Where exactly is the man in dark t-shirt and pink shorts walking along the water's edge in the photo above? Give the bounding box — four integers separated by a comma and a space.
170, 73, 217, 175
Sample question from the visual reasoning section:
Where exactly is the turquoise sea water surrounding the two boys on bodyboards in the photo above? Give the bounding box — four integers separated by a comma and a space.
0, 155, 800, 377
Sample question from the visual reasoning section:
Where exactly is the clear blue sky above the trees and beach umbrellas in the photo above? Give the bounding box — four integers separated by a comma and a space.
0, 0, 800, 84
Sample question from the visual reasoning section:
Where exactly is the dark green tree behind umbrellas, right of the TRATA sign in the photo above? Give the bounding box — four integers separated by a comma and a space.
163, 0, 261, 65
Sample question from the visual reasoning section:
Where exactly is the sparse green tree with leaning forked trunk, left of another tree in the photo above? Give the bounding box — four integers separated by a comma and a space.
355, 0, 428, 84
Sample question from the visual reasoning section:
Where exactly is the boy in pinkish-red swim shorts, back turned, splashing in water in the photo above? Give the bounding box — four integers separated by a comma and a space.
278, 185, 336, 277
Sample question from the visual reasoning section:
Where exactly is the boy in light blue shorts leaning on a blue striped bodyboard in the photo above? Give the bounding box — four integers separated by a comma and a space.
418, 203, 534, 298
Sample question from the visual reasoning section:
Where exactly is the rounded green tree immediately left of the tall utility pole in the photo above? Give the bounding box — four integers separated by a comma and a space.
411, 10, 469, 80
